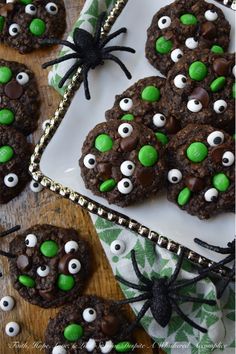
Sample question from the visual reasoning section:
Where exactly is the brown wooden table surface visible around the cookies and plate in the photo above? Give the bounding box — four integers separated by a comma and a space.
0, 0, 158, 354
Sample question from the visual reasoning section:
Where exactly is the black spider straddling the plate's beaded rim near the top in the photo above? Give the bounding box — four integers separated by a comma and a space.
42, 12, 135, 100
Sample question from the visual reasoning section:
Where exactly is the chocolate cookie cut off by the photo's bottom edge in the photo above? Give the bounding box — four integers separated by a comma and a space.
45, 296, 133, 354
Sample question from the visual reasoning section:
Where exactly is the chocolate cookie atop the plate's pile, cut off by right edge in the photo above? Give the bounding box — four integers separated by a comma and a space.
165, 51, 235, 133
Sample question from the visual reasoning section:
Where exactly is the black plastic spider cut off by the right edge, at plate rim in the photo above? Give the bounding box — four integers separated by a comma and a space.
194, 238, 235, 299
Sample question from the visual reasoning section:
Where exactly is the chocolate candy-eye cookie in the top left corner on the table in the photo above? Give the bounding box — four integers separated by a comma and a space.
0, 0, 66, 54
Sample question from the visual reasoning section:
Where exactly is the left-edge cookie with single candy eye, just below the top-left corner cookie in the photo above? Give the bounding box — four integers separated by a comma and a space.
0, 59, 40, 135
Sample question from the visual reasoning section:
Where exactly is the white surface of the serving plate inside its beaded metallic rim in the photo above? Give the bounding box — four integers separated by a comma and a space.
40, 0, 235, 261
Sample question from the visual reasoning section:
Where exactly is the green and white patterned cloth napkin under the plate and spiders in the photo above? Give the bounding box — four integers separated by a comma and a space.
49, 0, 235, 354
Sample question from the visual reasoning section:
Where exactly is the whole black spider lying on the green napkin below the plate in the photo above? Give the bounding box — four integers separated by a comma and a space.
116, 249, 216, 333
